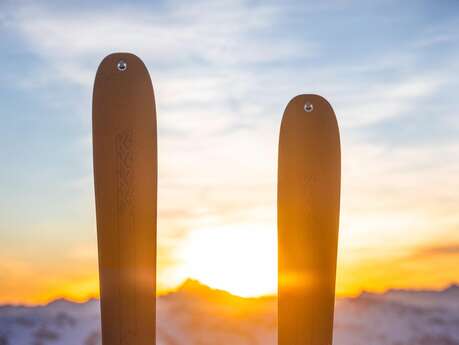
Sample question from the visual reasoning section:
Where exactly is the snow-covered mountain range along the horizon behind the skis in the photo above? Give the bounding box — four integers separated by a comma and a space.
0, 280, 459, 345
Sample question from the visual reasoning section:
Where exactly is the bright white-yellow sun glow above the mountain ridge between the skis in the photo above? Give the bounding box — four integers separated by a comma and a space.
183, 225, 277, 297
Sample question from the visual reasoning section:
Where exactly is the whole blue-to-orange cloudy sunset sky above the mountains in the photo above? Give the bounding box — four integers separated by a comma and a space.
0, 0, 459, 303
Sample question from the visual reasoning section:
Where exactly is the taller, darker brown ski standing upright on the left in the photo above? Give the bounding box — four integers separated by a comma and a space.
92, 53, 157, 345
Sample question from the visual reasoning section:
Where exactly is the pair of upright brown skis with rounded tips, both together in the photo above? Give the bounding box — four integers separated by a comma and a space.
93, 53, 340, 345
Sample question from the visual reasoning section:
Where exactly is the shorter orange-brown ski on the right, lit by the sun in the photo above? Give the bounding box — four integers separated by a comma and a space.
277, 95, 341, 345
